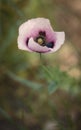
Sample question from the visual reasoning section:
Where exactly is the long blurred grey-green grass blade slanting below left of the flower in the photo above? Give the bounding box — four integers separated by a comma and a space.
7, 71, 42, 90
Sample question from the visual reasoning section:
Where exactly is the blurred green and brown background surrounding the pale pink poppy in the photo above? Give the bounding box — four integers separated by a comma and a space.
0, 0, 81, 130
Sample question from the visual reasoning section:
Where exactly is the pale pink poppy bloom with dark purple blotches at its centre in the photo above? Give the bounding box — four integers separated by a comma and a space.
18, 18, 65, 53
